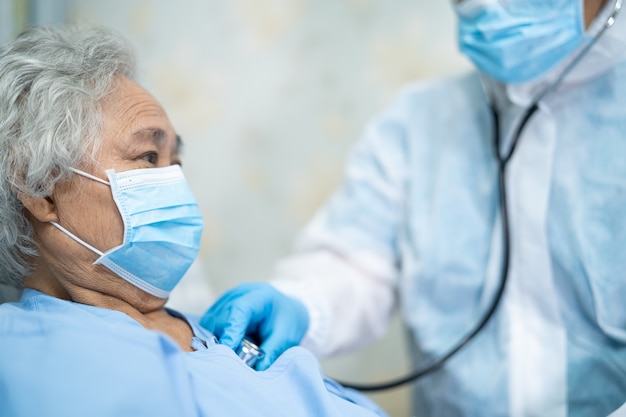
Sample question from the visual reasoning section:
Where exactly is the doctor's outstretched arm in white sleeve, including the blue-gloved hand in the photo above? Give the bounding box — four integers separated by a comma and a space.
202, 109, 407, 369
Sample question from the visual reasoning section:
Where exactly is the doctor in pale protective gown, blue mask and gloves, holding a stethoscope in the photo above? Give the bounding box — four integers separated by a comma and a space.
202, 0, 626, 417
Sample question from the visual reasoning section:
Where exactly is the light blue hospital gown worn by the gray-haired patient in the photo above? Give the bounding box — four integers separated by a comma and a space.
0, 289, 385, 417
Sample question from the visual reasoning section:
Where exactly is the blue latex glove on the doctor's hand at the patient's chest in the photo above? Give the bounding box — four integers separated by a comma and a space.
200, 283, 309, 371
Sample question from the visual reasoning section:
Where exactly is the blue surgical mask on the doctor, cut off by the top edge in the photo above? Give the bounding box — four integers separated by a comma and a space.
455, 0, 586, 83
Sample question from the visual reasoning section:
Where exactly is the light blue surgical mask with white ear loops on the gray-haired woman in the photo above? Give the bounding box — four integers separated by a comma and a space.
52, 165, 203, 298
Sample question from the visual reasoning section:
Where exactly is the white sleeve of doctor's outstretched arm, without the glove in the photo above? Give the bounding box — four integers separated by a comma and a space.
272, 90, 408, 357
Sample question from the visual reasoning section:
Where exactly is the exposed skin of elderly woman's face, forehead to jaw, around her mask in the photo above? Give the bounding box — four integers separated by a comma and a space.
41, 77, 180, 298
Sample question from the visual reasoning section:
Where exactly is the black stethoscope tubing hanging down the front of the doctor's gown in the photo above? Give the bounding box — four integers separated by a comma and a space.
339, 0, 623, 391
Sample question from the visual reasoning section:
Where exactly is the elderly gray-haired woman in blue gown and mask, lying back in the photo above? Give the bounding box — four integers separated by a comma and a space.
0, 28, 383, 417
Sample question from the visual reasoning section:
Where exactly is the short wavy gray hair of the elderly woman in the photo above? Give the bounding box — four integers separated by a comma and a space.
0, 27, 135, 287
